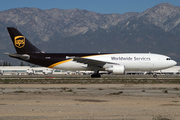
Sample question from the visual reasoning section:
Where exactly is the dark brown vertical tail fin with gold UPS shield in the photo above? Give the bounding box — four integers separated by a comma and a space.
7, 27, 43, 54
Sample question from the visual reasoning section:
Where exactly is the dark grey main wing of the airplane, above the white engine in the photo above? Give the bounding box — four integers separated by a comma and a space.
73, 57, 116, 68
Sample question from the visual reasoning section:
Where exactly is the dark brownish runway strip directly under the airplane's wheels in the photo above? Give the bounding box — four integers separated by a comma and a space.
0, 75, 180, 84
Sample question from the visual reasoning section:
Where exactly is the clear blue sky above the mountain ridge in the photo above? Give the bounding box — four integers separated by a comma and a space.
0, 0, 180, 14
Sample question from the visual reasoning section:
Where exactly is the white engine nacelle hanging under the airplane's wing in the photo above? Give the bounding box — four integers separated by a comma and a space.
105, 65, 125, 74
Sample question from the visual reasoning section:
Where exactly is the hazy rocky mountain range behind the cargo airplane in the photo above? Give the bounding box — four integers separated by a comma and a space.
0, 3, 180, 65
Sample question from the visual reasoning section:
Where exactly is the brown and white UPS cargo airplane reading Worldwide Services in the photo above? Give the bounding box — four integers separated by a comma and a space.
5, 27, 176, 77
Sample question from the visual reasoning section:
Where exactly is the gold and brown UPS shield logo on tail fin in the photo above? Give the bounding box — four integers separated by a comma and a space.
14, 36, 25, 48
